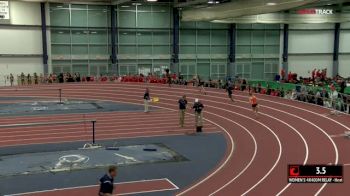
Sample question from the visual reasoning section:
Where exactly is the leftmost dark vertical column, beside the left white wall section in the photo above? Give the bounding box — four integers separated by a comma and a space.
40, 2, 49, 74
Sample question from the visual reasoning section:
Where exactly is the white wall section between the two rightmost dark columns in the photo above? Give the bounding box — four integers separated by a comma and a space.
288, 24, 334, 77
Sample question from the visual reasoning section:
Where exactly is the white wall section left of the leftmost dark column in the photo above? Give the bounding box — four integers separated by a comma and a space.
0, 1, 43, 85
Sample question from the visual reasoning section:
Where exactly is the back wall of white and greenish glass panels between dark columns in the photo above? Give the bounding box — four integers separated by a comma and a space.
0, 1, 350, 83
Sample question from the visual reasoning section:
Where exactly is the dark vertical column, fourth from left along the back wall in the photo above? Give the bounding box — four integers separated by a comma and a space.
227, 24, 237, 78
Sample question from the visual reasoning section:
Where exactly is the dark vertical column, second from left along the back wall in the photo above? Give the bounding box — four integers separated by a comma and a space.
110, 5, 119, 75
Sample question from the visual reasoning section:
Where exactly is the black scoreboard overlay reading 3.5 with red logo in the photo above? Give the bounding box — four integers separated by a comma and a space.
288, 165, 344, 183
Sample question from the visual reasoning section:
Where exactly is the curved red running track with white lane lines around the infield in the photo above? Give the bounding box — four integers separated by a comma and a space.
2, 84, 350, 195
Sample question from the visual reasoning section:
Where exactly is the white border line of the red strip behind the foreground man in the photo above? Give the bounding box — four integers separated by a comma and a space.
5, 178, 179, 196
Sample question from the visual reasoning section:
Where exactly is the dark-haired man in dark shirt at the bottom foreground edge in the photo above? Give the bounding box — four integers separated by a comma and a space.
98, 166, 117, 196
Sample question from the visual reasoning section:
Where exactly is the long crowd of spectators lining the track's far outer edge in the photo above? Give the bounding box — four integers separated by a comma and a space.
2, 69, 350, 111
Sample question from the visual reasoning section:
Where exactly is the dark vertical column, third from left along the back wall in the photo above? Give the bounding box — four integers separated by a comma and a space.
170, 8, 180, 74
